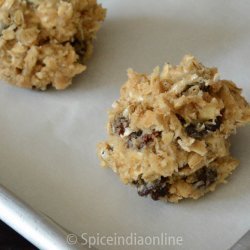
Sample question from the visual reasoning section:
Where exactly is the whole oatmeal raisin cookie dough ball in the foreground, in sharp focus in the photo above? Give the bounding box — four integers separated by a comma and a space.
98, 55, 250, 202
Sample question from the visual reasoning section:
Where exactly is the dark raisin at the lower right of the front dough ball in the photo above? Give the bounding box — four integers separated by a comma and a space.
196, 167, 218, 188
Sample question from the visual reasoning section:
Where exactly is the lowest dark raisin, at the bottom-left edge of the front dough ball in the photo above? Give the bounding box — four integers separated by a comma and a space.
136, 177, 169, 200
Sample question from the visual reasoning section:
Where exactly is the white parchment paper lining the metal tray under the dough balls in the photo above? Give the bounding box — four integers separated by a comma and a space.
0, 0, 250, 250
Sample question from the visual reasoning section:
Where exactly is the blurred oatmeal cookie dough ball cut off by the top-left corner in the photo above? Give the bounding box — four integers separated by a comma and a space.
0, 0, 105, 90
